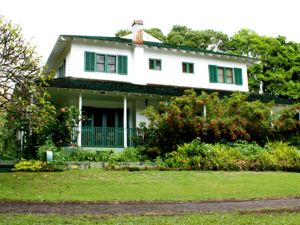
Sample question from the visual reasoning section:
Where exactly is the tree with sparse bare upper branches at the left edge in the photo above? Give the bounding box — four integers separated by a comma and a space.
0, 17, 55, 157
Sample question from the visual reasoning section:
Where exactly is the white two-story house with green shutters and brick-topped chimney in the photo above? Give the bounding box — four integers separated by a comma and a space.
47, 20, 254, 148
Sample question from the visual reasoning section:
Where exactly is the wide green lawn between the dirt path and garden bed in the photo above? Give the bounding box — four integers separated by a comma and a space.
0, 169, 300, 201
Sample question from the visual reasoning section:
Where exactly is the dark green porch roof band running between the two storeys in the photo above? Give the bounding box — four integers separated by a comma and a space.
49, 77, 298, 104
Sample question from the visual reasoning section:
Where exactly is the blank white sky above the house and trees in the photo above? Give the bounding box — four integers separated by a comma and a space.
0, 0, 300, 62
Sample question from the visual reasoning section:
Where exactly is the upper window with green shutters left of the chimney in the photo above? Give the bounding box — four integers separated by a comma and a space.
84, 52, 128, 75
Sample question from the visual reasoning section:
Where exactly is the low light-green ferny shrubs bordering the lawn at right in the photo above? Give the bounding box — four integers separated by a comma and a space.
157, 140, 300, 171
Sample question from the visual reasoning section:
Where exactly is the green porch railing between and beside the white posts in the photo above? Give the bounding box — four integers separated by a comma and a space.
81, 126, 137, 148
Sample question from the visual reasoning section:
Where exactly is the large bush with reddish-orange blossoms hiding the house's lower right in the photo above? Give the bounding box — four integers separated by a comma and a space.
142, 90, 273, 155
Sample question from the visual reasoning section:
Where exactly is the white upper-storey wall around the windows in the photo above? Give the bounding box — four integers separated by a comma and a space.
62, 41, 248, 91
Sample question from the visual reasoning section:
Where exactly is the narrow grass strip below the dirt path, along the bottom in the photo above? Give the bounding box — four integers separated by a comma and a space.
0, 213, 300, 225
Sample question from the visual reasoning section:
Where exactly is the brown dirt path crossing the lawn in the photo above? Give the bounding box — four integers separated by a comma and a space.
0, 198, 300, 215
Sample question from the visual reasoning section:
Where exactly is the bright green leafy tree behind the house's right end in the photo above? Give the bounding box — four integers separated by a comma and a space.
226, 29, 300, 99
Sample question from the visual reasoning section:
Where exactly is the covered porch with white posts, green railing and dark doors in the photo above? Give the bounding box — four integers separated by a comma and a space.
48, 88, 162, 148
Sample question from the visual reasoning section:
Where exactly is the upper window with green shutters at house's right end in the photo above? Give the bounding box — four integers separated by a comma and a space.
208, 65, 243, 85
